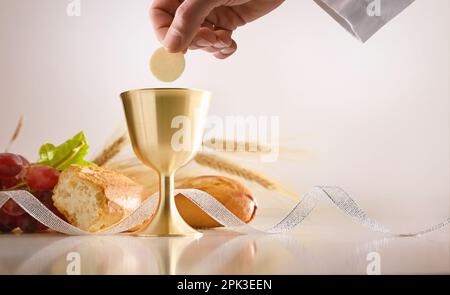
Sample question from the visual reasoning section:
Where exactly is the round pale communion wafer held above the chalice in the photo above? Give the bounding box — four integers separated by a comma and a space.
150, 47, 185, 82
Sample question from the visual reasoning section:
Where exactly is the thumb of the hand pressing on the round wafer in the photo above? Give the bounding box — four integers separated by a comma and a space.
163, 0, 224, 52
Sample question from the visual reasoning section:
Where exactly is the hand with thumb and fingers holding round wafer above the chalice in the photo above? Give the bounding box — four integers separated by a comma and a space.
150, 0, 284, 82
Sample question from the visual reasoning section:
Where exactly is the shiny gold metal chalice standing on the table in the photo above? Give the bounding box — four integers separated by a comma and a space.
121, 88, 211, 236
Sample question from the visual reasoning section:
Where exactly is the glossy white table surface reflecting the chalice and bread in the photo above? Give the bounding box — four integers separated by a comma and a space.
0, 208, 450, 274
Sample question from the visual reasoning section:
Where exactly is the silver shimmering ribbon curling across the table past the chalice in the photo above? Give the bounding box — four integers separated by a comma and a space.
0, 186, 450, 237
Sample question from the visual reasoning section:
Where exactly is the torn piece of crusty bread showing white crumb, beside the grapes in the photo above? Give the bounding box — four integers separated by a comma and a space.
53, 165, 148, 232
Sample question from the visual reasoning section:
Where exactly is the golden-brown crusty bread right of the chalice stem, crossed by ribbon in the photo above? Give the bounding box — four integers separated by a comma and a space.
175, 176, 258, 228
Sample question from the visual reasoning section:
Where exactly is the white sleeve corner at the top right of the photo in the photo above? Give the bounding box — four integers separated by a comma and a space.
314, 0, 415, 42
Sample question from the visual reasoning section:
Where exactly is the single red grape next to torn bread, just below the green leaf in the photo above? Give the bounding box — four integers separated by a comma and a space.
26, 166, 59, 191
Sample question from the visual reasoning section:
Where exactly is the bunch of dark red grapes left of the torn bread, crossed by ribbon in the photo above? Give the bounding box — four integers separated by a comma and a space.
0, 153, 63, 233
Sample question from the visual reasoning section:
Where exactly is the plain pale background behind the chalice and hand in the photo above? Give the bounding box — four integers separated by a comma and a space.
0, 0, 450, 224
